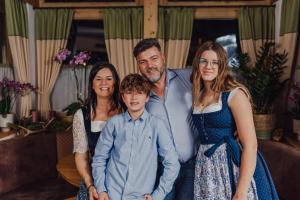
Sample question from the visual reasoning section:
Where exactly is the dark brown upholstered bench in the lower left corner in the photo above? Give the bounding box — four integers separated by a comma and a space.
0, 133, 77, 200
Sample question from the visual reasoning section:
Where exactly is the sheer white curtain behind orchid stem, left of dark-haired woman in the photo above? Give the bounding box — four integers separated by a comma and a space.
51, 67, 91, 111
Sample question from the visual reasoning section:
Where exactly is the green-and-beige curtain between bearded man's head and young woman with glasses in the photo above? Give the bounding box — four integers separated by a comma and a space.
157, 8, 194, 69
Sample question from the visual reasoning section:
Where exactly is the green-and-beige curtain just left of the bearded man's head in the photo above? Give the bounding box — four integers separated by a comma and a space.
103, 8, 143, 79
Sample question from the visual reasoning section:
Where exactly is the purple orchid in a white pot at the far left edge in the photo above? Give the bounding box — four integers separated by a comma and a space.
0, 77, 37, 132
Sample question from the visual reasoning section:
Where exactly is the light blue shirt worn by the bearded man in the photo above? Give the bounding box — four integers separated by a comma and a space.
146, 69, 197, 163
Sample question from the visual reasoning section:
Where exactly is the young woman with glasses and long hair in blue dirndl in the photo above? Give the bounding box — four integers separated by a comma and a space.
191, 41, 278, 200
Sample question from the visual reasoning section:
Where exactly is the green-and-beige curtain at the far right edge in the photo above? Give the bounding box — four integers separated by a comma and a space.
279, 0, 300, 80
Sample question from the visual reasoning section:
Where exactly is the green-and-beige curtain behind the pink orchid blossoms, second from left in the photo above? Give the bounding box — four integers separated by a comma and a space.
36, 9, 74, 119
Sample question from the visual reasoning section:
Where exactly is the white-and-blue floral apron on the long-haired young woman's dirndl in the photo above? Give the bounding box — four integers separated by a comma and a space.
194, 144, 258, 200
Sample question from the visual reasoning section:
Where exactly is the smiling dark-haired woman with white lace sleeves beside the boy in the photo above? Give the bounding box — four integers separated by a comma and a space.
73, 63, 122, 200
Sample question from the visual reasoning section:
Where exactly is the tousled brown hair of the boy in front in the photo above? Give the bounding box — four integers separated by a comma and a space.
120, 74, 151, 96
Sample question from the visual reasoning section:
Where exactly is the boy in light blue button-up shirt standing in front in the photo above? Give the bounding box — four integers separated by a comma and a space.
92, 74, 180, 200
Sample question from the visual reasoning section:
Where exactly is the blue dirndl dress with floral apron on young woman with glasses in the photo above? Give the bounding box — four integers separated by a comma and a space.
192, 92, 278, 200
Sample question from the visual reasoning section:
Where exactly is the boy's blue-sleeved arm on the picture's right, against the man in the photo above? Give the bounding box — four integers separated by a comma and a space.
152, 118, 180, 200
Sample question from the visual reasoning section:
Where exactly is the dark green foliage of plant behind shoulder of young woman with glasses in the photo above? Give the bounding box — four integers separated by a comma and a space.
238, 42, 288, 114
